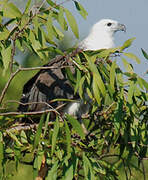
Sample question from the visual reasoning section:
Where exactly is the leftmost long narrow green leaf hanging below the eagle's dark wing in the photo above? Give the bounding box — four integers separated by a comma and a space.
34, 114, 45, 149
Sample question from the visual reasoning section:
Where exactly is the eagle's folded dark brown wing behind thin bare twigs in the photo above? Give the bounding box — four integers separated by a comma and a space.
18, 53, 78, 112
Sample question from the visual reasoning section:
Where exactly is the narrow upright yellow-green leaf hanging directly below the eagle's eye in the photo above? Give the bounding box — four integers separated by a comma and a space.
110, 61, 116, 92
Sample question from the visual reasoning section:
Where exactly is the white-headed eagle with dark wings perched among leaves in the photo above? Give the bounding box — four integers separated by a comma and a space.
18, 19, 126, 120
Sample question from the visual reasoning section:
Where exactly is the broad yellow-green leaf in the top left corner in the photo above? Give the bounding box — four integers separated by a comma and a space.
3, 3, 22, 18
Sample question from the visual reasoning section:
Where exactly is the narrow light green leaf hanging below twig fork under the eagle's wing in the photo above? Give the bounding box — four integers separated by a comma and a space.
51, 116, 59, 155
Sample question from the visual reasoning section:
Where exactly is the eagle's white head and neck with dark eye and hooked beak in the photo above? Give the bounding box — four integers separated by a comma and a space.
79, 19, 126, 50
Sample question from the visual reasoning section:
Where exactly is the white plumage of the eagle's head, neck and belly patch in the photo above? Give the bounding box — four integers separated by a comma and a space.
64, 19, 126, 117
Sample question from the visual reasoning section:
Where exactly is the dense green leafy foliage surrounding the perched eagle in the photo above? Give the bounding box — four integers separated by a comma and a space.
0, 0, 148, 180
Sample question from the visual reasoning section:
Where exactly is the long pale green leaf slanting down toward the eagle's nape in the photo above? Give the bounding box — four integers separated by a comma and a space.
64, 8, 79, 38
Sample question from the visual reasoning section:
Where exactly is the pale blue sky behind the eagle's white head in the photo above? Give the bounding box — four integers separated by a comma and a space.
63, 0, 148, 80
